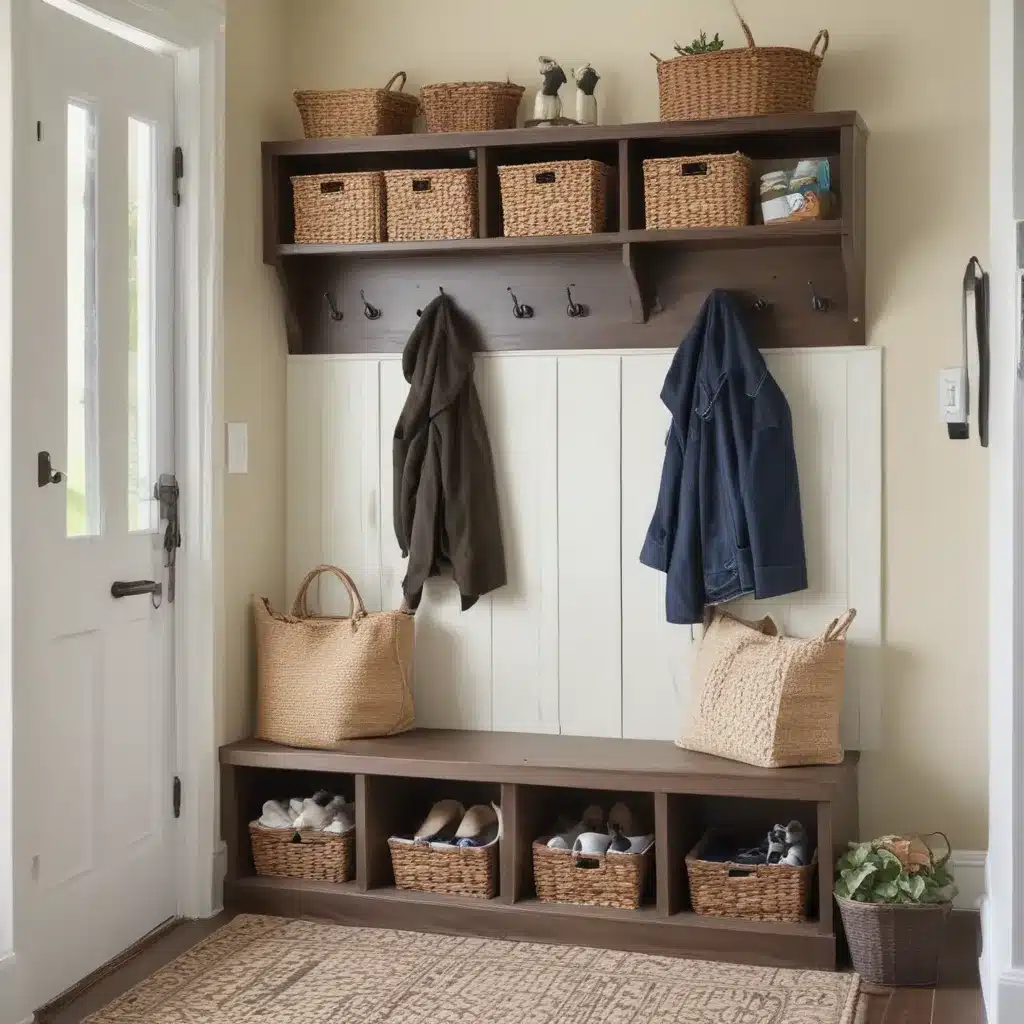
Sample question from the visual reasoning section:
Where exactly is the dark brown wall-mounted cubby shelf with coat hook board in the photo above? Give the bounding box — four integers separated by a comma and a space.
263, 112, 866, 353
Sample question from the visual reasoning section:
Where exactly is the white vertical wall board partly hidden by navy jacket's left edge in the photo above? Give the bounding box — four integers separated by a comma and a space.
622, 351, 701, 739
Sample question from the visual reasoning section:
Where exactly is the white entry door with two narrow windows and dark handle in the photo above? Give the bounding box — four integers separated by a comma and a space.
13, 0, 176, 995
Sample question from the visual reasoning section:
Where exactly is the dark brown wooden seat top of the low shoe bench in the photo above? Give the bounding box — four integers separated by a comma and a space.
220, 729, 858, 800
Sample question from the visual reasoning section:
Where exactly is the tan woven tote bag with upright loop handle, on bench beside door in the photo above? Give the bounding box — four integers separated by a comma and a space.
253, 565, 414, 750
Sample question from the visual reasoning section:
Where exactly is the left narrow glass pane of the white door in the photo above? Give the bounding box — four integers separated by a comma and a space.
66, 103, 99, 537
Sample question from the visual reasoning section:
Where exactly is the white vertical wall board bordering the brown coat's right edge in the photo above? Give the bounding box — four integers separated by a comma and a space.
475, 355, 558, 732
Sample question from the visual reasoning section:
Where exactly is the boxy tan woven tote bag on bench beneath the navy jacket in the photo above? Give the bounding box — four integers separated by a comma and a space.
676, 608, 857, 768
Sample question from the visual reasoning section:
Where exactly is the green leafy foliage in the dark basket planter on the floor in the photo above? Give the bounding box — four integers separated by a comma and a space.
836, 833, 956, 905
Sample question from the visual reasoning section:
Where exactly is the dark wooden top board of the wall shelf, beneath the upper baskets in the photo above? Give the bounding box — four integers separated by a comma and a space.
263, 111, 864, 157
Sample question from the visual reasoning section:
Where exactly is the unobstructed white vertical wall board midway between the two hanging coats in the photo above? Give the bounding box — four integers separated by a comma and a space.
552, 354, 623, 736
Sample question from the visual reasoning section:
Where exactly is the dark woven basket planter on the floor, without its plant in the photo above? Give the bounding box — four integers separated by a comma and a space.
836, 896, 952, 986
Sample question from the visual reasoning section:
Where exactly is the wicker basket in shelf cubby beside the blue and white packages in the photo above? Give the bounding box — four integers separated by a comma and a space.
643, 153, 751, 228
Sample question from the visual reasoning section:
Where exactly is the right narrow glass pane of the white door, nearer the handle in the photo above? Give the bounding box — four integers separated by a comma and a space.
128, 118, 158, 530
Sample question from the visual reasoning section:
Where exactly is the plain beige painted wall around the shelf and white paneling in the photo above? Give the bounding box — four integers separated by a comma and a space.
225, 0, 987, 849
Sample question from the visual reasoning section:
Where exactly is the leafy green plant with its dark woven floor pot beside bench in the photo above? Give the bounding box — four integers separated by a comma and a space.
836, 833, 956, 985
